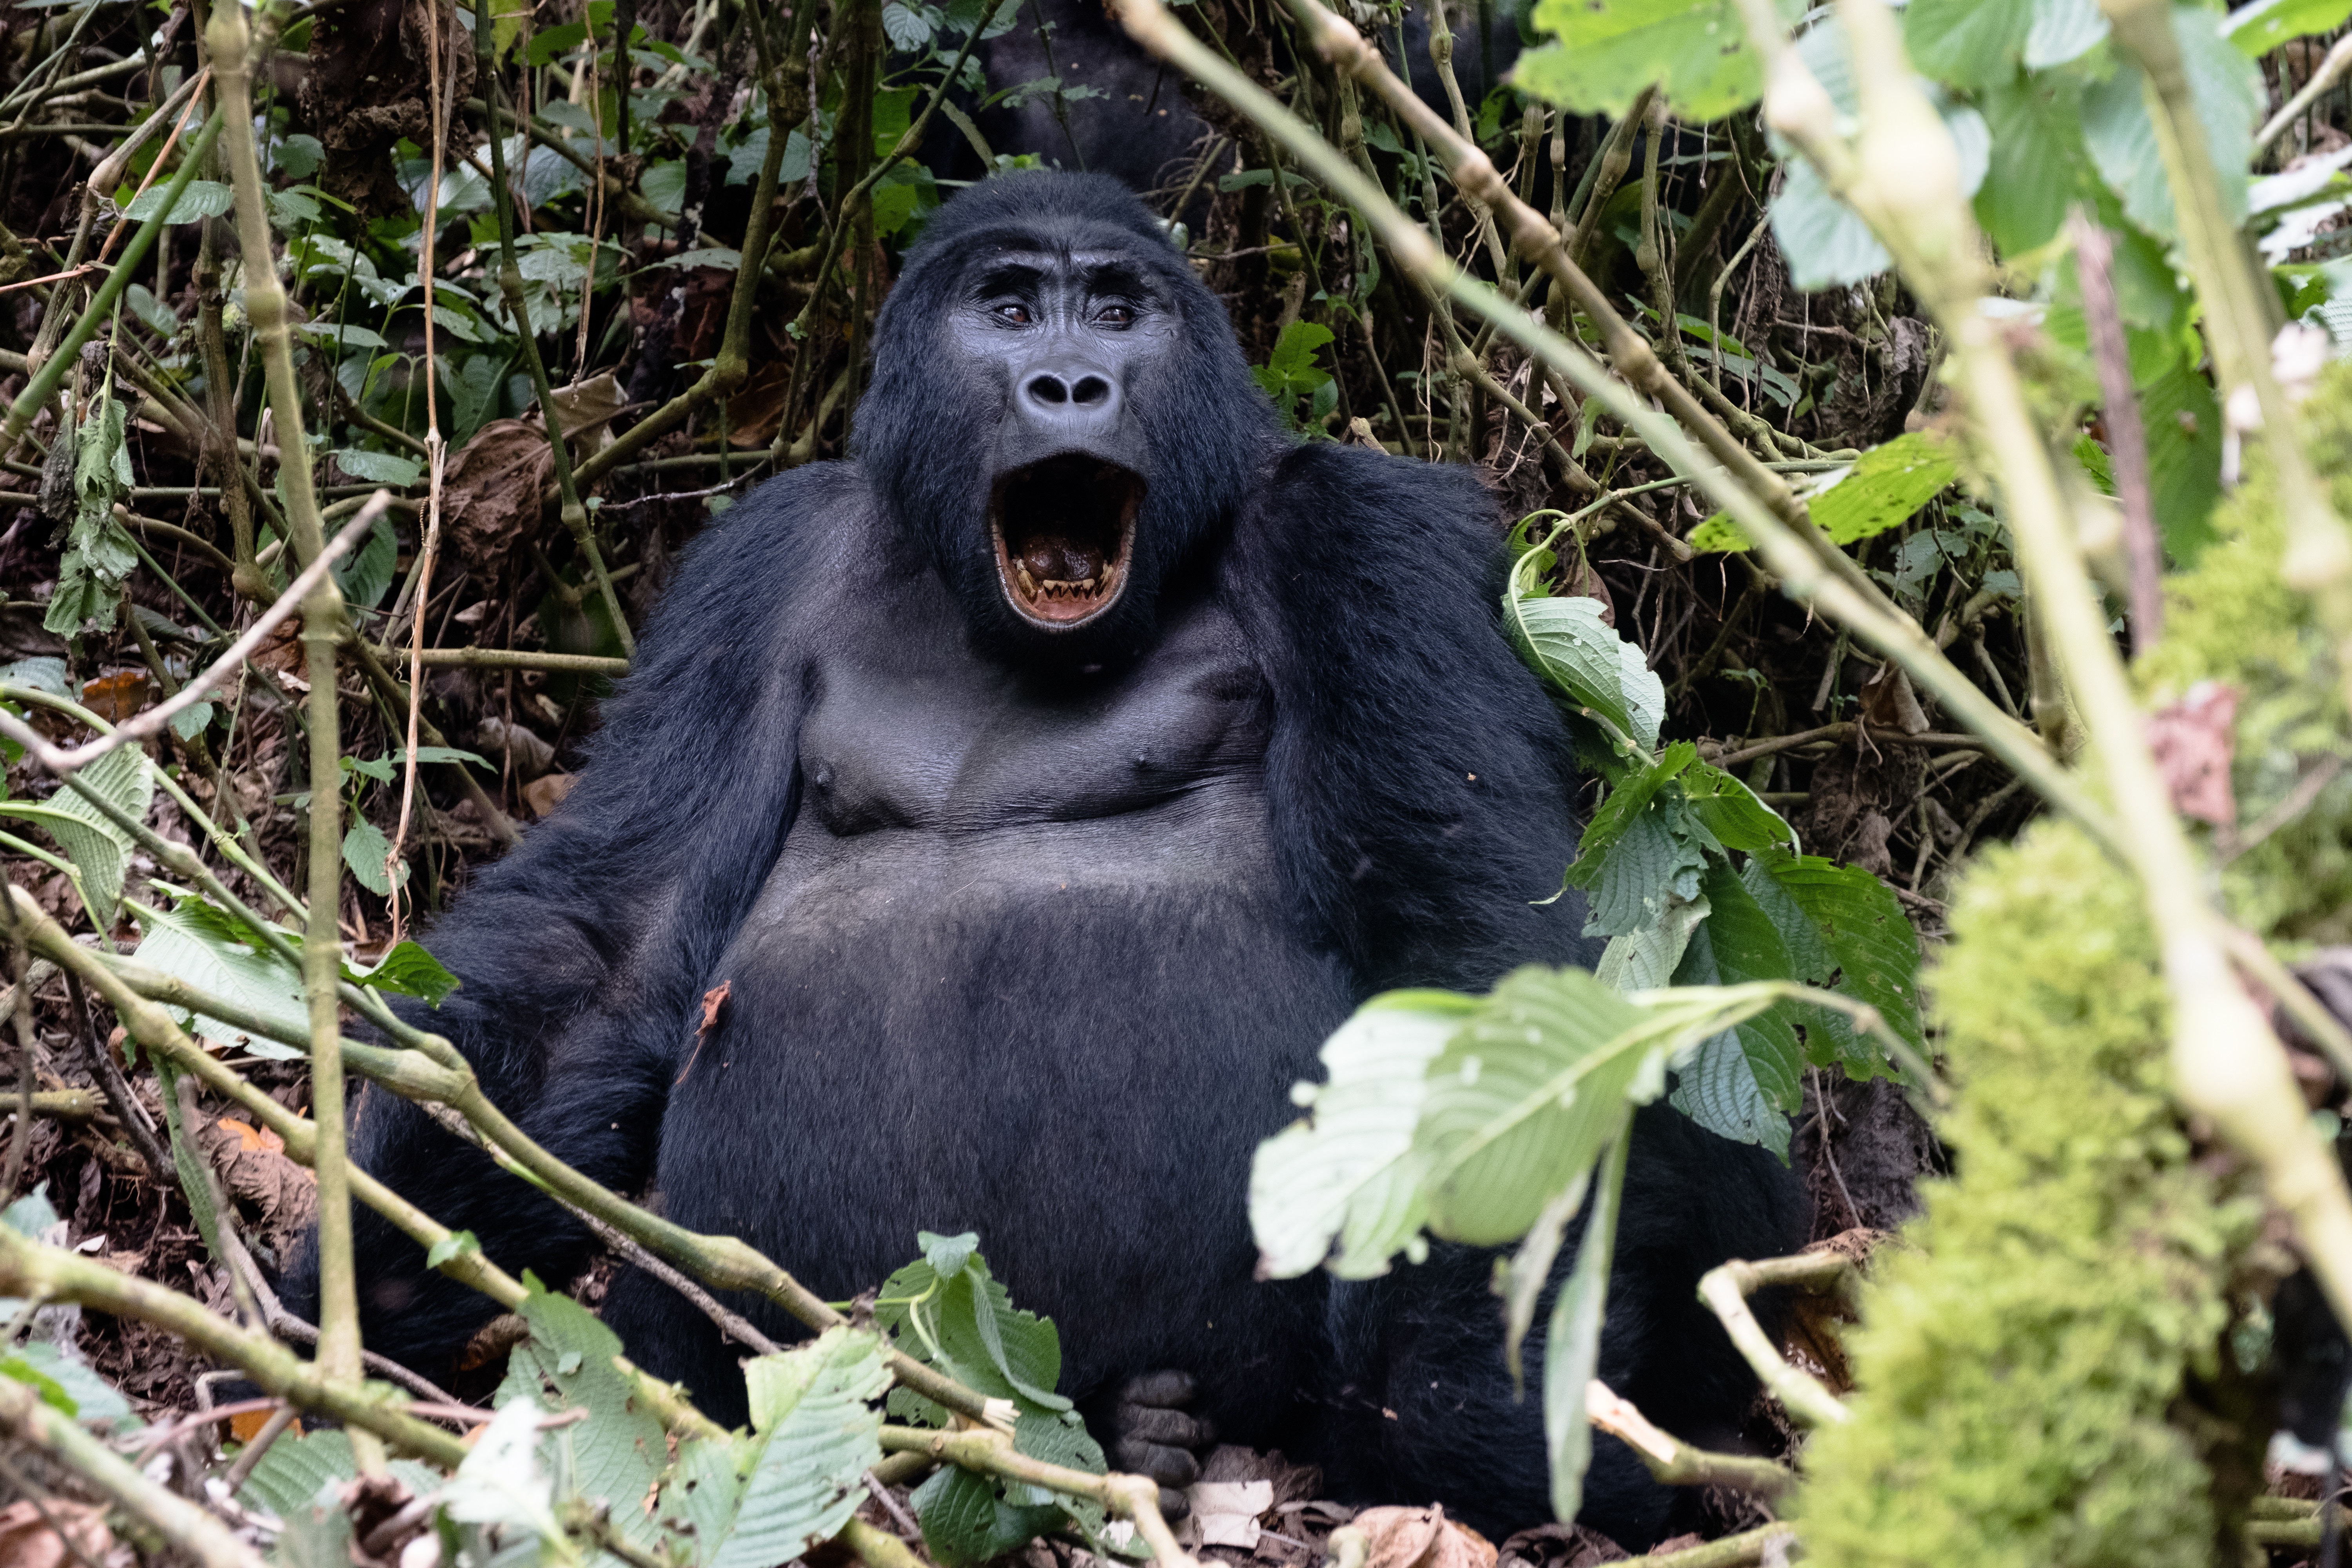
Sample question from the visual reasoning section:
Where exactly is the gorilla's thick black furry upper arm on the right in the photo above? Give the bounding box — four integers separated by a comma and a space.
1225, 442, 1592, 995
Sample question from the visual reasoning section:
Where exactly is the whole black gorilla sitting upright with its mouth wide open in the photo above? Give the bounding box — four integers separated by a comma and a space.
303, 174, 1802, 1544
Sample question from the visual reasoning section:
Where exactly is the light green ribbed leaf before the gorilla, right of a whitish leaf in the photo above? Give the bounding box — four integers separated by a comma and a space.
1414, 969, 1646, 1246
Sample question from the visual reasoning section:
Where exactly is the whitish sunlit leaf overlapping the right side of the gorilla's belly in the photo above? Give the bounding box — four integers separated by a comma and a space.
1249, 990, 1475, 1279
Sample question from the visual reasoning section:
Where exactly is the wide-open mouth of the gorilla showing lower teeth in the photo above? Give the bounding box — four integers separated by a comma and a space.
988, 454, 1143, 630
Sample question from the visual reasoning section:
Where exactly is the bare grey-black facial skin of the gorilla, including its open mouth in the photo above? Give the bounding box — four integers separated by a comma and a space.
953, 252, 1176, 635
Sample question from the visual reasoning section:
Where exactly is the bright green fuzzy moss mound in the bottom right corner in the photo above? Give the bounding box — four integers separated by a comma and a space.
1797, 823, 2260, 1568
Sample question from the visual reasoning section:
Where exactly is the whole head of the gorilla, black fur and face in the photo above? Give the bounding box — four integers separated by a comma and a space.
856, 174, 1279, 661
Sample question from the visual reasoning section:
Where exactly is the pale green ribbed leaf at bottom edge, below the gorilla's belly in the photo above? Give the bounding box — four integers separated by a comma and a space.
682, 1326, 889, 1568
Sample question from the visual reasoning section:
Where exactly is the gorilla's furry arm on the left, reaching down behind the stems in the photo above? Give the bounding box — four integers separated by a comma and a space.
318, 468, 856, 1375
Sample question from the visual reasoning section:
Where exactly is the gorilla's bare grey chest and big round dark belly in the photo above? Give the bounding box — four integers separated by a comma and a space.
659, 611, 1352, 1429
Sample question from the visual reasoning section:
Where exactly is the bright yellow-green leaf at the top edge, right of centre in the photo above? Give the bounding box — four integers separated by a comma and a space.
1510, 0, 1795, 122
